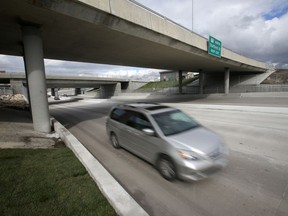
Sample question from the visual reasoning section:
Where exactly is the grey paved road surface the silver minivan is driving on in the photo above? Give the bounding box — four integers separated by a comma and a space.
50, 100, 288, 216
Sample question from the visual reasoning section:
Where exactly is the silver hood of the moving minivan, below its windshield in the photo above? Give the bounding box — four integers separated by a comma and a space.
166, 127, 222, 155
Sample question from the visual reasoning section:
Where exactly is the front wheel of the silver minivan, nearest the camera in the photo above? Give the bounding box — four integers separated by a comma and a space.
157, 156, 177, 181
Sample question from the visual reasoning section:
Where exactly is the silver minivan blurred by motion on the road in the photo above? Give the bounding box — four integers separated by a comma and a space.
106, 103, 228, 181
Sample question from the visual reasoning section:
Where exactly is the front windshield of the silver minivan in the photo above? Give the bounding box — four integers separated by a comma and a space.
152, 110, 199, 136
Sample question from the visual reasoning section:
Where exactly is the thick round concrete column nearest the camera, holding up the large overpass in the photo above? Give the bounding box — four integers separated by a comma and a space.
22, 26, 51, 133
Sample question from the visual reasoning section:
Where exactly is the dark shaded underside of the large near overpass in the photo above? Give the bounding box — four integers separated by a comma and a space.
0, 0, 268, 72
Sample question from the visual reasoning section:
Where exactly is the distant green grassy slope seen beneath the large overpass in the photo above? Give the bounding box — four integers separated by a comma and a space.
139, 77, 198, 90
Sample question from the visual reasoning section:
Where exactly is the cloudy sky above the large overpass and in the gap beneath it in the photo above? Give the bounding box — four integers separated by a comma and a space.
0, 0, 288, 79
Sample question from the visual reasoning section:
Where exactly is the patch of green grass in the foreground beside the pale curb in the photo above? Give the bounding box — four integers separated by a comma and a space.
0, 148, 116, 216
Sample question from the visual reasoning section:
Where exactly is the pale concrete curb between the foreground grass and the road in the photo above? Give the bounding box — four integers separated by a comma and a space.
51, 118, 149, 216
